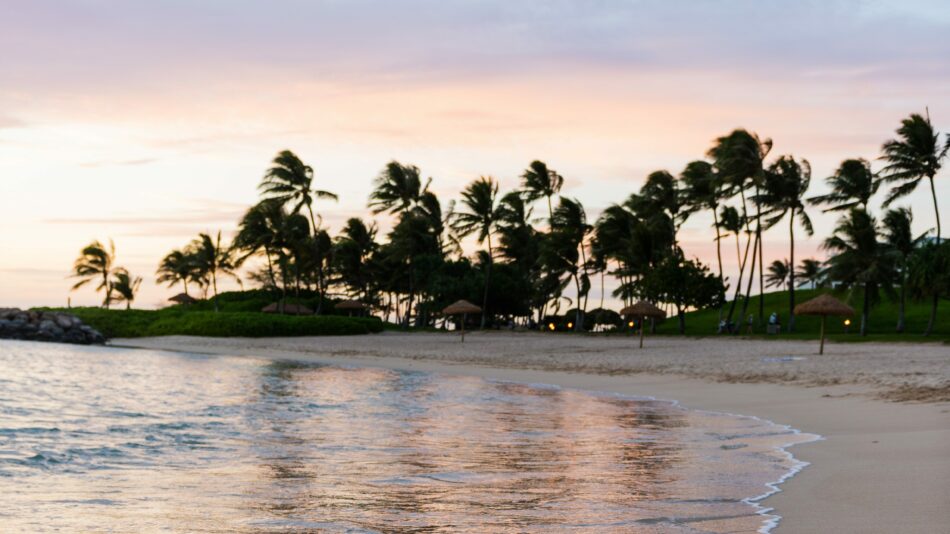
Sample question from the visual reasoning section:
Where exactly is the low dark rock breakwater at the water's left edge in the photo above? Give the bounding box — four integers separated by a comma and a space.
0, 308, 106, 345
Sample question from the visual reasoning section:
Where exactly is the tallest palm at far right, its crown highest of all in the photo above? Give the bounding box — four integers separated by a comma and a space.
881, 113, 950, 333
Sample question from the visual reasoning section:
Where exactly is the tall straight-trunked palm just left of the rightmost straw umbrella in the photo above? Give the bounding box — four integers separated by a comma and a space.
759, 156, 815, 332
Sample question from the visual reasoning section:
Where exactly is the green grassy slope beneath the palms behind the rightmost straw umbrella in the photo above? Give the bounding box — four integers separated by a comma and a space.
657, 289, 950, 341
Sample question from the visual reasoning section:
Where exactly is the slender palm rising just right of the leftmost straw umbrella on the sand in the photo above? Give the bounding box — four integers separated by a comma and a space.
450, 176, 499, 328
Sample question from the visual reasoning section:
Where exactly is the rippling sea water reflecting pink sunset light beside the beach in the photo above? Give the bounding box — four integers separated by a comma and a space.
0, 342, 820, 533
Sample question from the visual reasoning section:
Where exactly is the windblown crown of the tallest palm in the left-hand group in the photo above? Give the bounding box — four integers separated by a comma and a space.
258, 150, 337, 232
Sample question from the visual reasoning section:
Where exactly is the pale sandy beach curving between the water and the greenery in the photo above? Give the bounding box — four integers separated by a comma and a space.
113, 333, 950, 533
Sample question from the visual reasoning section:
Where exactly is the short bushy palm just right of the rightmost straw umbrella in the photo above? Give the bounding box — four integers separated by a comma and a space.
822, 208, 897, 336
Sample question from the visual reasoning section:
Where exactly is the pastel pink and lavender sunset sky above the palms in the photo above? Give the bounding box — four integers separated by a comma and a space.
0, 0, 950, 308
